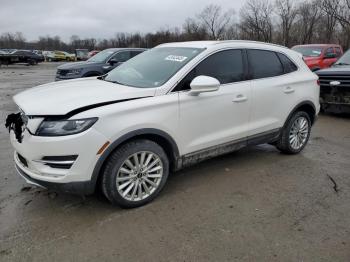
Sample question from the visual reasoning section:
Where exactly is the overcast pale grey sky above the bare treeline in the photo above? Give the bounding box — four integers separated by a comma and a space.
0, 0, 245, 41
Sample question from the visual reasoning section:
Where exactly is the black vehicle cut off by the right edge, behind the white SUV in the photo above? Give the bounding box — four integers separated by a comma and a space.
316, 50, 350, 113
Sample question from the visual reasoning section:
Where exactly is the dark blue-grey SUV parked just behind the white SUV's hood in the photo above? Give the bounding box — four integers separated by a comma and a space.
56, 48, 145, 81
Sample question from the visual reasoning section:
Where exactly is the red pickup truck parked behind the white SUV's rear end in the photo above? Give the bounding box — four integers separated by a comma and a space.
292, 44, 343, 71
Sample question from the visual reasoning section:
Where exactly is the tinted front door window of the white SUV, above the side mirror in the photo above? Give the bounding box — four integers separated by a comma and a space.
173, 50, 244, 91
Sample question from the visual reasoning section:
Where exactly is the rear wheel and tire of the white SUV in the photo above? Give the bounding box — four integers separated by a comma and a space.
276, 111, 311, 154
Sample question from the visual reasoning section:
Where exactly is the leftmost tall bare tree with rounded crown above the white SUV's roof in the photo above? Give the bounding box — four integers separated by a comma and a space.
197, 5, 234, 40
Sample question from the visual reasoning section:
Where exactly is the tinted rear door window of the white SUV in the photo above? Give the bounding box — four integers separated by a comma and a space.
248, 50, 284, 79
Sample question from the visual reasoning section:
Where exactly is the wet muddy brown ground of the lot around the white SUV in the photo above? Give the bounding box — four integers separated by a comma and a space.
0, 63, 350, 262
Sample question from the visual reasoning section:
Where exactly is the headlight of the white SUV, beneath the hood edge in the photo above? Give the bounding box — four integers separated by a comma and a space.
36, 117, 98, 136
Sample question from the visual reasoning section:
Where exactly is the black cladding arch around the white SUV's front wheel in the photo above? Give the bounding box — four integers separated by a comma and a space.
91, 128, 179, 191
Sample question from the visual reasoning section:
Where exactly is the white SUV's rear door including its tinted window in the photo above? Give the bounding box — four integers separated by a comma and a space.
247, 49, 302, 136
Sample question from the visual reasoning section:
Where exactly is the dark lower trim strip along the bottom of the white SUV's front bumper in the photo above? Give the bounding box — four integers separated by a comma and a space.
15, 163, 95, 195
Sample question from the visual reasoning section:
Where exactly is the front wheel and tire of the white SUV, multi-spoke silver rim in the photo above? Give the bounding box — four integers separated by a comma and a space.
102, 139, 169, 208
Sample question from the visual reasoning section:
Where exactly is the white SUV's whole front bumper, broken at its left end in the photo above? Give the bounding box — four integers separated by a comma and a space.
10, 124, 106, 195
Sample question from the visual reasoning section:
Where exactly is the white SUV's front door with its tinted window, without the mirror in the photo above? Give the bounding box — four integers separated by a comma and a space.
175, 49, 251, 154
